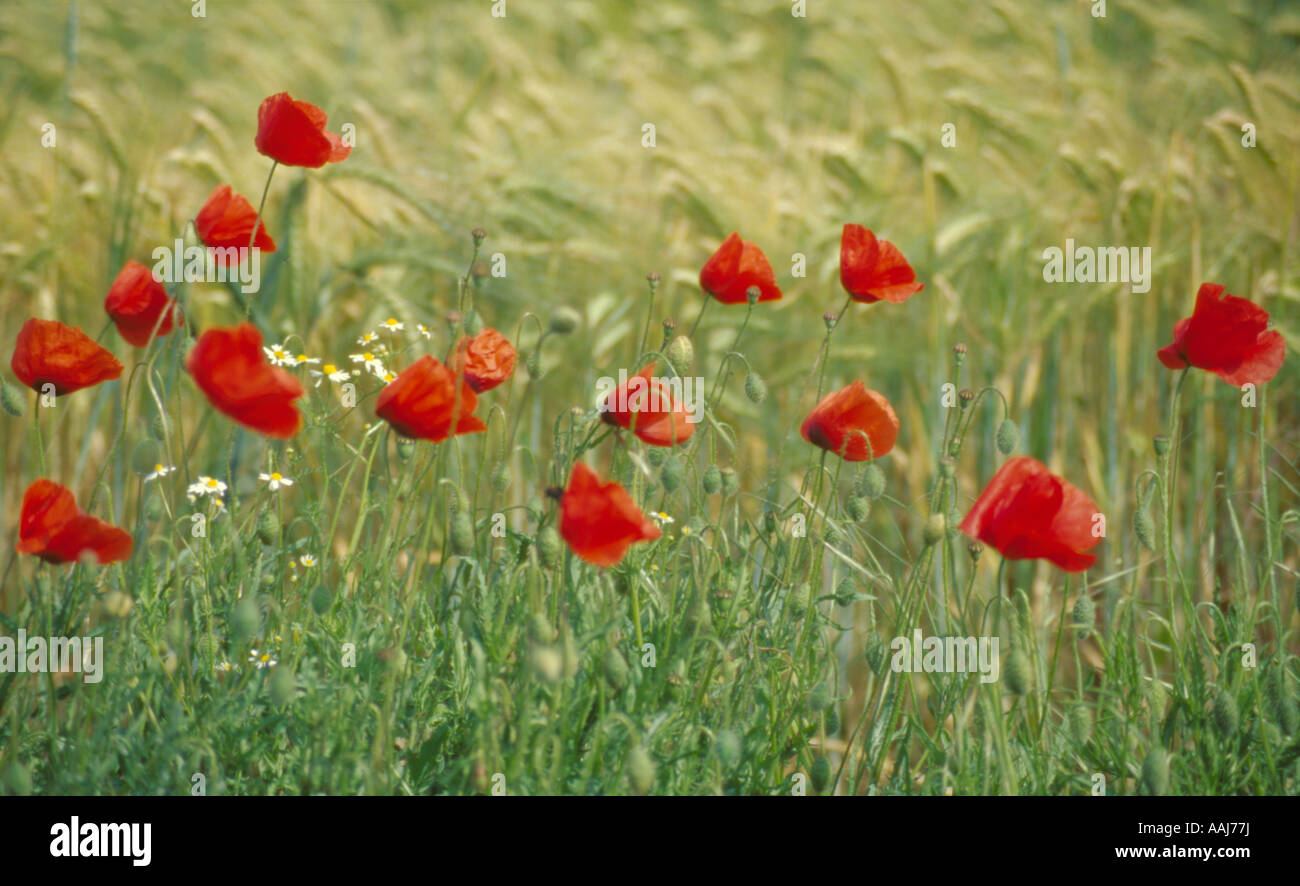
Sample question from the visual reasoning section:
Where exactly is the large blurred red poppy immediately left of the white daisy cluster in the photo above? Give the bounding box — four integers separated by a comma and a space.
185, 323, 303, 439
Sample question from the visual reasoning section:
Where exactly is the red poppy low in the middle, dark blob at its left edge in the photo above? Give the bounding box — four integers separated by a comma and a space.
560, 461, 662, 566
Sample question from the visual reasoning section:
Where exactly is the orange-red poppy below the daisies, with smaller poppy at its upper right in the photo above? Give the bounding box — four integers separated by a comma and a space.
374, 355, 488, 443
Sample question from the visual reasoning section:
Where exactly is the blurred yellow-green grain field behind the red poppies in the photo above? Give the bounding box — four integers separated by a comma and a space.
0, 0, 1300, 784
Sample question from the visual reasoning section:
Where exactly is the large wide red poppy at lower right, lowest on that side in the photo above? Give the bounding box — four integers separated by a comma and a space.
961, 456, 1101, 572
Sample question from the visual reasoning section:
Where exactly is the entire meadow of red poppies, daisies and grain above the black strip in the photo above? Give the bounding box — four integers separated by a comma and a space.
0, 0, 1300, 795
